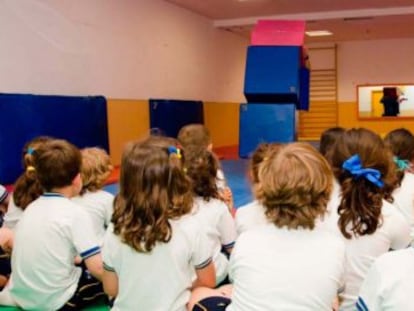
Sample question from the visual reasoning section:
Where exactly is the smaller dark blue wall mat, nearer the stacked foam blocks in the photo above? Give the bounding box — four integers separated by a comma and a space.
149, 99, 204, 137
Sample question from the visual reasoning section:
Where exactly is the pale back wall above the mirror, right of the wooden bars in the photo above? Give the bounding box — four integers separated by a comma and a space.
338, 39, 414, 102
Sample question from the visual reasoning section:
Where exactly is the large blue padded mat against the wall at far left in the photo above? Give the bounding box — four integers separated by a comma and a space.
0, 94, 109, 184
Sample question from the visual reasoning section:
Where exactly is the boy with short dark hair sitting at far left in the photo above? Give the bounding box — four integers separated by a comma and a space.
0, 140, 103, 310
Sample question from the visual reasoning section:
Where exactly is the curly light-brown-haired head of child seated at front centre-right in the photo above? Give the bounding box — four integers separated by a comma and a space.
256, 143, 333, 229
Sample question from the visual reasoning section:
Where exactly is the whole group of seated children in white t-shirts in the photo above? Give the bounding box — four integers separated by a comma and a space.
0, 124, 414, 311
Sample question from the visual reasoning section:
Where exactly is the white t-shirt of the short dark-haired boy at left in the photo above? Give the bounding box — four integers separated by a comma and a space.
9, 193, 100, 310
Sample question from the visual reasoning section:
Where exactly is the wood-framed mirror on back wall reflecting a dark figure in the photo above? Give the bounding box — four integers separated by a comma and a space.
357, 83, 414, 118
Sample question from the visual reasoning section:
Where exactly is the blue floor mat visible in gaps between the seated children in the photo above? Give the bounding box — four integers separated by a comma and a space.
105, 159, 253, 208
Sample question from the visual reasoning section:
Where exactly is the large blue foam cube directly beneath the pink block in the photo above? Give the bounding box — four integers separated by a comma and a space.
244, 46, 301, 103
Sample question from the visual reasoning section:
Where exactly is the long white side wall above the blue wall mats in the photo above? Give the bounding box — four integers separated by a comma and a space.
0, 0, 248, 101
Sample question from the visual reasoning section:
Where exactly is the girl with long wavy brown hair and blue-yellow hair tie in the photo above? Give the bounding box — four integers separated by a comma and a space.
103, 137, 215, 310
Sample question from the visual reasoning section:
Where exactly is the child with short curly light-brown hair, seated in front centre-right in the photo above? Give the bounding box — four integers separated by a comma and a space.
189, 143, 345, 311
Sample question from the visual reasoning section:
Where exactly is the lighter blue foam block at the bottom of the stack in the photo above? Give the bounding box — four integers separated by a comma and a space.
239, 103, 296, 158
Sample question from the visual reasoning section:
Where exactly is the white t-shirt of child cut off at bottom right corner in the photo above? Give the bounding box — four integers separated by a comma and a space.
357, 247, 414, 311
